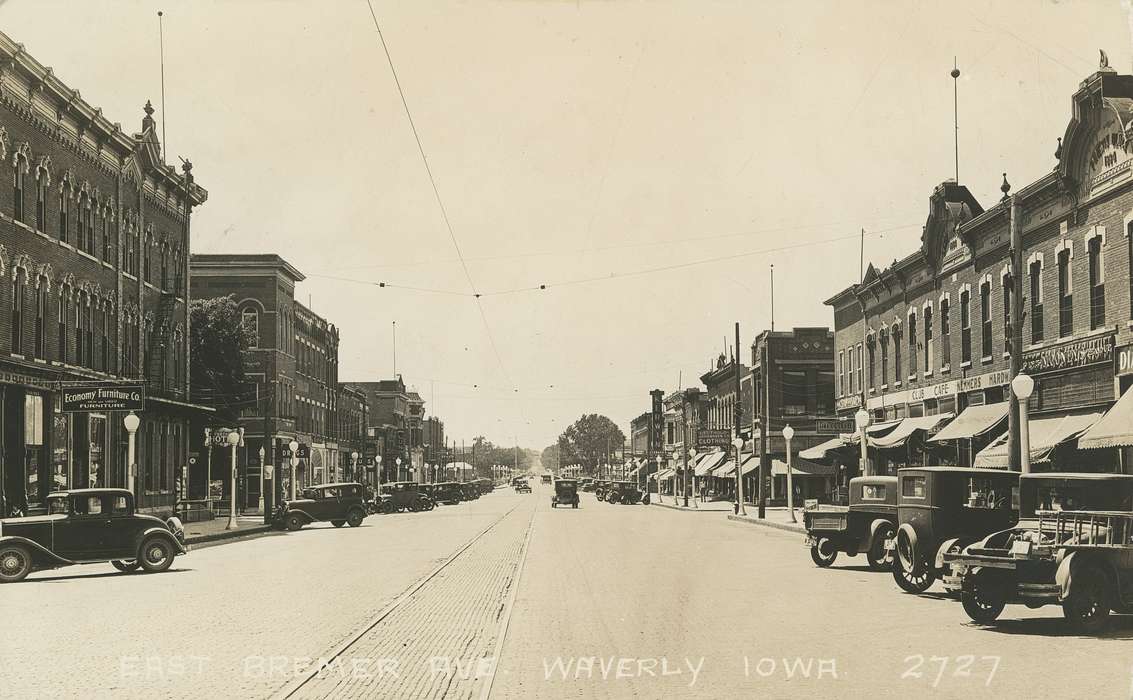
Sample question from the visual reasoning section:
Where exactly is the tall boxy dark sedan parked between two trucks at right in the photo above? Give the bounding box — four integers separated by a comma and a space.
885, 467, 1019, 594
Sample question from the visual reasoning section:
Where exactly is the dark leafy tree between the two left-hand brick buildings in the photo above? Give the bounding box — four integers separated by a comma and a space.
189, 294, 252, 419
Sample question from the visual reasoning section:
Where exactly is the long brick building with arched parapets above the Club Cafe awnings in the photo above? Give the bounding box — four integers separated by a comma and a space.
827, 65, 1133, 470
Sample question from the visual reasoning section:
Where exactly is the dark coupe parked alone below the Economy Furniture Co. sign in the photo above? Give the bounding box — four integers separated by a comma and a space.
0, 488, 188, 583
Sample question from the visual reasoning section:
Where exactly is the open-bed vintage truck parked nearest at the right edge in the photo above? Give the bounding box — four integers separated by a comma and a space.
945, 472, 1133, 634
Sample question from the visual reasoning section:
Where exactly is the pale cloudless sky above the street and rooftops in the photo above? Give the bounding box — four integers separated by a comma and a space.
0, 0, 1133, 449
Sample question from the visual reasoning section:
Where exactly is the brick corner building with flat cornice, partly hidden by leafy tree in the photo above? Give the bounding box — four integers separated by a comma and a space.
189, 254, 341, 498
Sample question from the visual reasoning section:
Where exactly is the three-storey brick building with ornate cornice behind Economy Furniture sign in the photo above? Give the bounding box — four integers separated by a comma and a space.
0, 33, 207, 514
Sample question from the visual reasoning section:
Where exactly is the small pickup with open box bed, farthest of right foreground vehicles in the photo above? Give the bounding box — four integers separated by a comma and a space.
802, 477, 897, 571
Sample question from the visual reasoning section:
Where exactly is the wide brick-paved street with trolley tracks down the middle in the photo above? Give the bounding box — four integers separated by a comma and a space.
0, 486, 1133, 698
